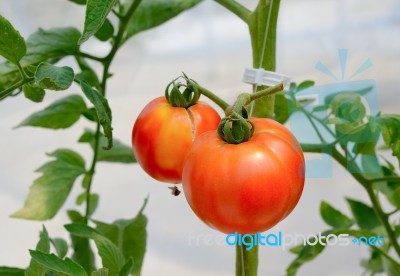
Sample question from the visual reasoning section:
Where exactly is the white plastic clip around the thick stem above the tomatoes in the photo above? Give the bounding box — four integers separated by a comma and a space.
243, 68, 290, 89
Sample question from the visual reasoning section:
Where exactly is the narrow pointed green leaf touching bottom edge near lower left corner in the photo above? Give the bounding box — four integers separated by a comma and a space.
29, 250, 87, 276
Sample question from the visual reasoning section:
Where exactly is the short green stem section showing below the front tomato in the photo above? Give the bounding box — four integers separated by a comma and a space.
236, 245, 258, 276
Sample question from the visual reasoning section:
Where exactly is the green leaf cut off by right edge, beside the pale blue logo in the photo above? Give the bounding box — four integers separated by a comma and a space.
380, 114, 400, 164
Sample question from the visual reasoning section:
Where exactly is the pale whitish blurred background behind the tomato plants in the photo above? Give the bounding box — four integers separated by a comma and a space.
0, 0, 400, 276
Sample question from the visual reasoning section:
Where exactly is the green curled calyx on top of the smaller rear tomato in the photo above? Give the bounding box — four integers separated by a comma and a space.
165, 74, 201, 108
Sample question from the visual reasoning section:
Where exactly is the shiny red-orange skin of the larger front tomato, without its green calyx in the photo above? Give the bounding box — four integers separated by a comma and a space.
182, 118, 305, 234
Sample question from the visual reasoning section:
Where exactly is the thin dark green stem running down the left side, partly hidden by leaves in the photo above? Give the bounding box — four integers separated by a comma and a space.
84, 0, 141, 224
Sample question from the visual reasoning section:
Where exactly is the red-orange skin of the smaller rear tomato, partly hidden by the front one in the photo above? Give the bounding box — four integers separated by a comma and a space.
132, 97, 220, 183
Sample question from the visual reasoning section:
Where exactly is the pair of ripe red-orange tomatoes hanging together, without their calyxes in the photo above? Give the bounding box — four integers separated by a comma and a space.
132, 94, 305, 234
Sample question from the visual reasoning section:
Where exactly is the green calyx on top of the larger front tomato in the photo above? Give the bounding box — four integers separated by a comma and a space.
217, 107, 255, 144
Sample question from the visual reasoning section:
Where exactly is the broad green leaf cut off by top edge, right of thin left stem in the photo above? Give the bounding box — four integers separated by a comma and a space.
124, 0, 201, 40
